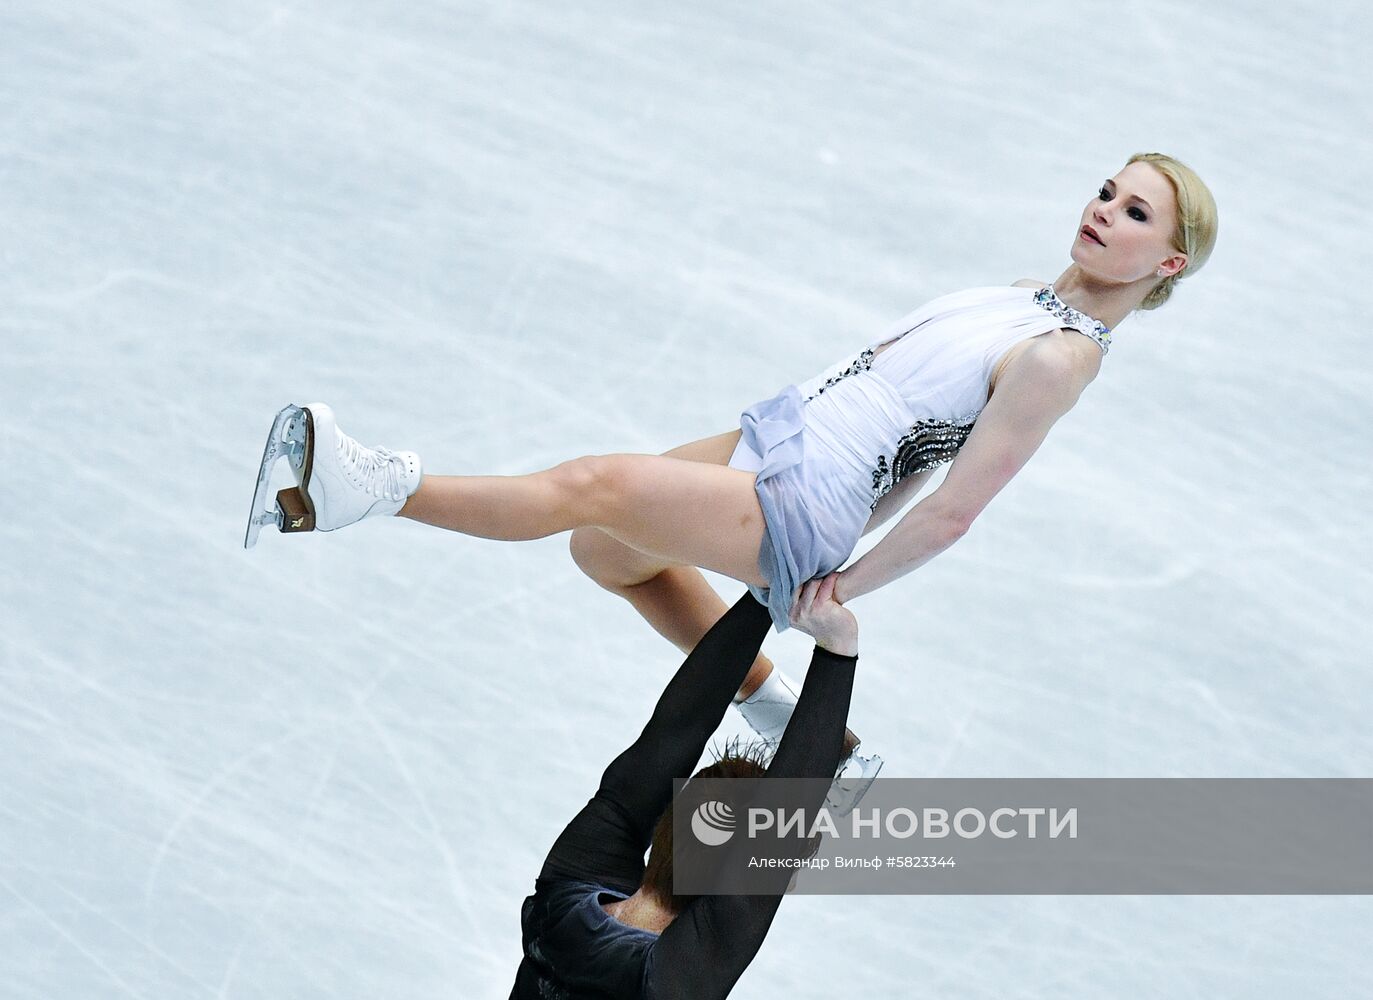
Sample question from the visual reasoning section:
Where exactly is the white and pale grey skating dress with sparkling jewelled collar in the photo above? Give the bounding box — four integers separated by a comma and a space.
729, 286, 1111, 630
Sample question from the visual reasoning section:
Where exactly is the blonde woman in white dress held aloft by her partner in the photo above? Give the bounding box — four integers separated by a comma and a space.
246, 152, 1216, 739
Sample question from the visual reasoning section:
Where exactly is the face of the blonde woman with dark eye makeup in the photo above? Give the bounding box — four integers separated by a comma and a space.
1072, 162, 1186, 283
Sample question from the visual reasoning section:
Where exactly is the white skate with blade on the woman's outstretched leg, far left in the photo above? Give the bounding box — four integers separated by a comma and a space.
243, 402, 422, 548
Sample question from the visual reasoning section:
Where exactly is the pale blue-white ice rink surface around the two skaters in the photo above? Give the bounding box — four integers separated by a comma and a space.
0, 0, 1373, 1000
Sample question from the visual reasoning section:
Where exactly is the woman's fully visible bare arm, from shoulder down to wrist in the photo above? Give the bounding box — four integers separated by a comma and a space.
835, 338, 1100, 603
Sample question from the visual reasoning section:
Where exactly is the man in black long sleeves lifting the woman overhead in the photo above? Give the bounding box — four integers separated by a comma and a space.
511, 577, 858, 1000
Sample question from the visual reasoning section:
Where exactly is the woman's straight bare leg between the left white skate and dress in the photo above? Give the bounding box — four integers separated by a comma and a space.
401, 455, 766, 585
